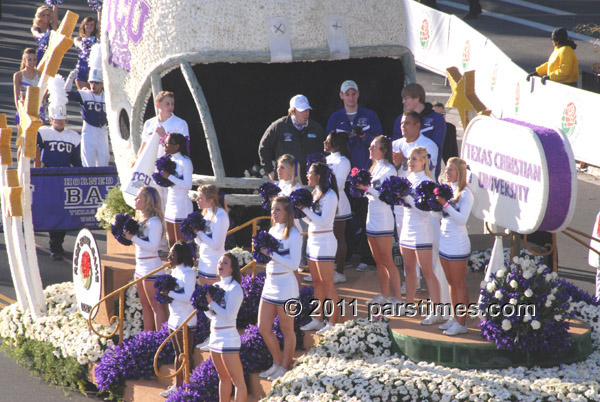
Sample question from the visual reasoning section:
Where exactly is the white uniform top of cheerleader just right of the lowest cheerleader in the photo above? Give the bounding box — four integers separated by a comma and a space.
266, 223, 302, 274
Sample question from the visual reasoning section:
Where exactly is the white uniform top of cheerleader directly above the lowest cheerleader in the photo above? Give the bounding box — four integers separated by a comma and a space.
195, 208, 229, 275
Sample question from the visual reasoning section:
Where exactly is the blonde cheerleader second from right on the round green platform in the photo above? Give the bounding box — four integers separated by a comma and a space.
400, 147, 443, 325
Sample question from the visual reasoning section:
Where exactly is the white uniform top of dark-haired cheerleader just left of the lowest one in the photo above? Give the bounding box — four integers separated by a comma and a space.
168, 264, 197, 329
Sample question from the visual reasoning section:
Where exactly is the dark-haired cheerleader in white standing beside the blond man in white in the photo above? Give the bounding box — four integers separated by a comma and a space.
160, 133, 194, 245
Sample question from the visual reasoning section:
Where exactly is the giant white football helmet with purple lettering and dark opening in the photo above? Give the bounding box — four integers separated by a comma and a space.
101, 0, 407, 196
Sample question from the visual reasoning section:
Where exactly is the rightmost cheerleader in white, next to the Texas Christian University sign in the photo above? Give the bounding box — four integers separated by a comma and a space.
436, 157, 473, 336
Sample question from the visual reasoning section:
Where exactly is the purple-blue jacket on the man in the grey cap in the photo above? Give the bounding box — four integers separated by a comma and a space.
326, 106, 383, 169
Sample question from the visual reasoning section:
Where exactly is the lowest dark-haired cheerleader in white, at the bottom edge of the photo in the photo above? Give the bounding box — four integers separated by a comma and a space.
205, 253, 248, 402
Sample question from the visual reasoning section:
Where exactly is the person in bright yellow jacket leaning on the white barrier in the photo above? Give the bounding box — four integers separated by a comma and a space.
527, 27, 579, 87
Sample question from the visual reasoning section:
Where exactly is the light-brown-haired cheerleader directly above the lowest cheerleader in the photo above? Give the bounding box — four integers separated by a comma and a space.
195, 184, 229, 285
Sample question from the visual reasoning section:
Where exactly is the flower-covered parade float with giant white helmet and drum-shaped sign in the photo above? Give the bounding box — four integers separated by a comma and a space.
0, 0, 600, 401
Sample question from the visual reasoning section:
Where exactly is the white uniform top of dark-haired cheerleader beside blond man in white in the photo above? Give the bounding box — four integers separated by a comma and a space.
165, 152, 194, 219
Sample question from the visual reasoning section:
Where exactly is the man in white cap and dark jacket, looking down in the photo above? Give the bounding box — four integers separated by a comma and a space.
258, 95, 325, 184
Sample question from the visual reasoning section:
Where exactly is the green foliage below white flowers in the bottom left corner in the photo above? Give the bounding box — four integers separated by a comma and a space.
0, 336, 96, 395
